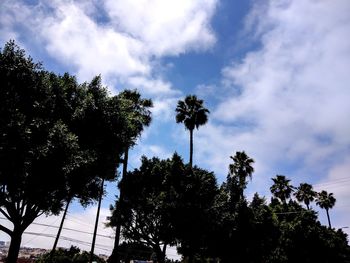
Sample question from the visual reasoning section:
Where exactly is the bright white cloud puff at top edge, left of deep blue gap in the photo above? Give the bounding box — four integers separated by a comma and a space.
105, 0, 217, 56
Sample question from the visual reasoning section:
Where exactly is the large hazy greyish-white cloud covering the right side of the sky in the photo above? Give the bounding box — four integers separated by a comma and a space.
197, 0, 350, 196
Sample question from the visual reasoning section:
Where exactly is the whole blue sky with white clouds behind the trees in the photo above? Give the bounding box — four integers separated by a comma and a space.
0, 0, 350, 257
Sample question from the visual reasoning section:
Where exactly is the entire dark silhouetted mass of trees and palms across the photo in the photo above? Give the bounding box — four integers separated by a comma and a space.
0, 41, 350, 263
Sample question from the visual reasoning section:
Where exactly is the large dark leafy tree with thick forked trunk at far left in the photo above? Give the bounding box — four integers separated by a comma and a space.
0, 41, 123, 262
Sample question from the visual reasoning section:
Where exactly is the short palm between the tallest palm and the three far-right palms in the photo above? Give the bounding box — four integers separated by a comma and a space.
229, 151, 254, 198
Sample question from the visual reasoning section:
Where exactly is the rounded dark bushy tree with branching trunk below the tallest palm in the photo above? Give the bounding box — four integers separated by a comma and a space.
110, 154, 216, 262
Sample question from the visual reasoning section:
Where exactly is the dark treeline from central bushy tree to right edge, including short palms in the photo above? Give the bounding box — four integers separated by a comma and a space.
110, 152, 350, 262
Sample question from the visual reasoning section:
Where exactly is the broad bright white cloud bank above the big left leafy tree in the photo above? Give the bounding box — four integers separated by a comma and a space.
0, 0, 217, 97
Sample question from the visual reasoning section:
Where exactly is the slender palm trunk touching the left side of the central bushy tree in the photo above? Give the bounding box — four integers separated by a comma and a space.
108, 148, 129, 263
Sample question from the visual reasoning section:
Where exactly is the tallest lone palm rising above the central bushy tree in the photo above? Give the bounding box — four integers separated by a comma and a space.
175, 95, 209, 167
